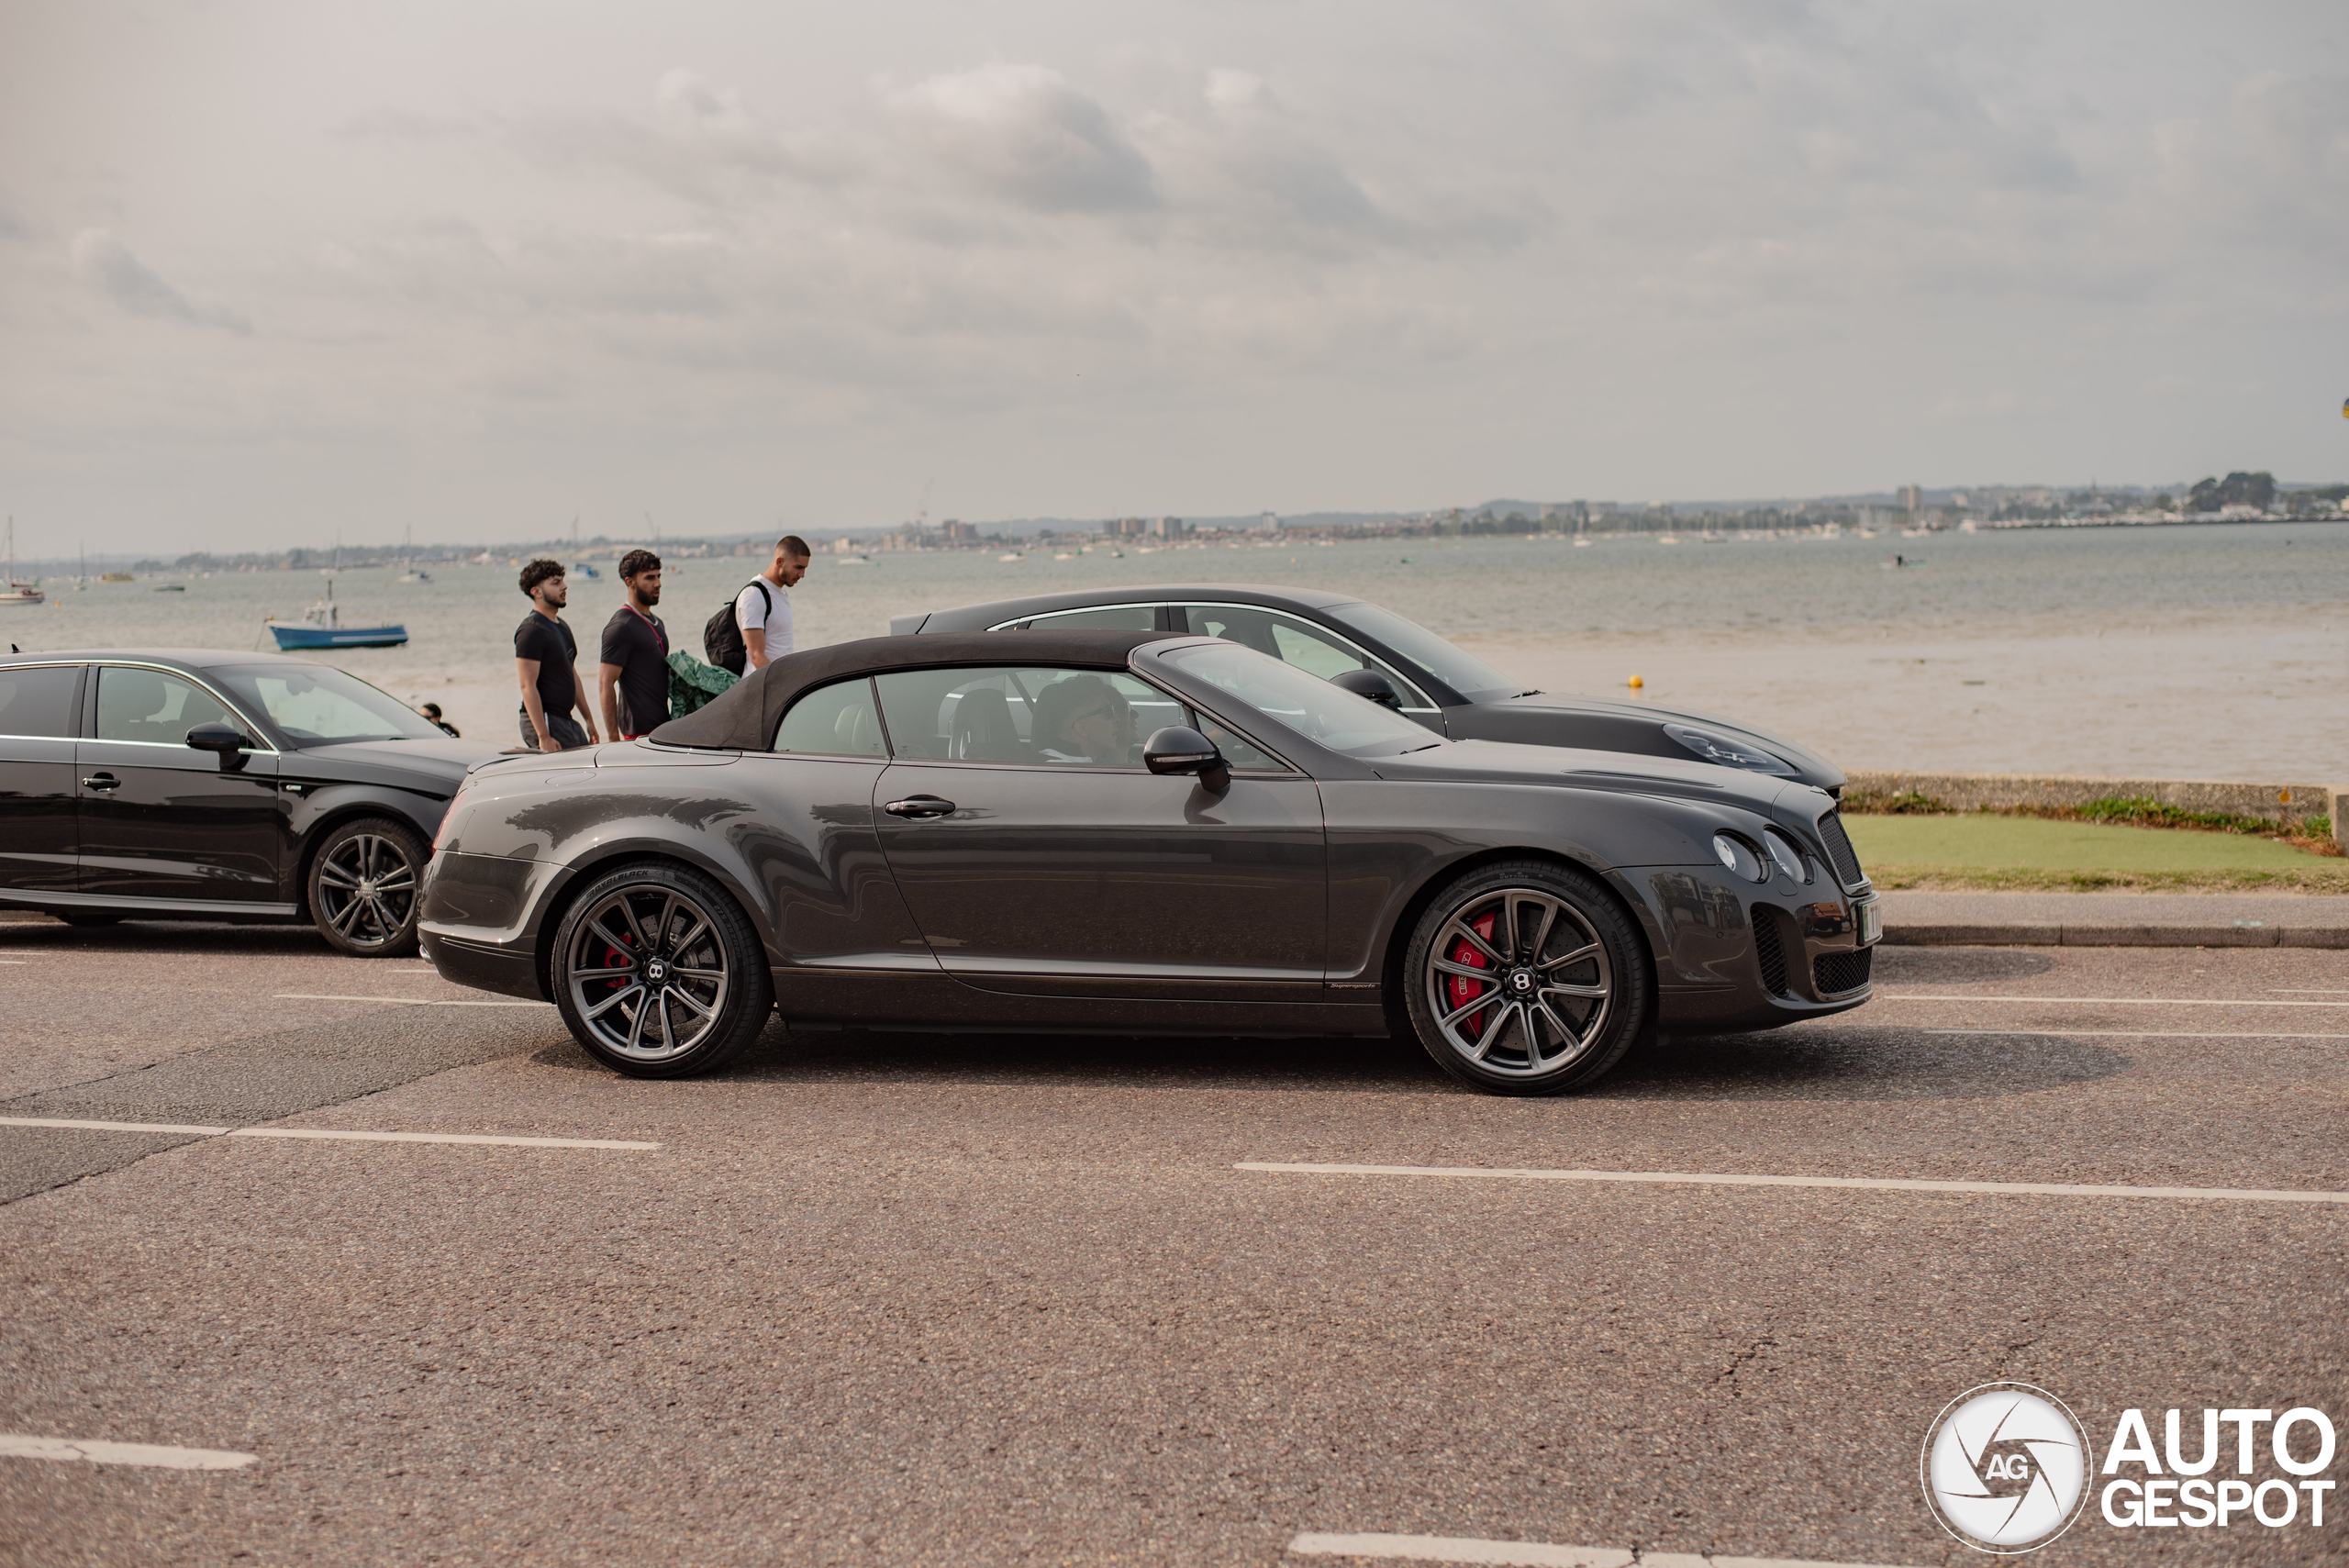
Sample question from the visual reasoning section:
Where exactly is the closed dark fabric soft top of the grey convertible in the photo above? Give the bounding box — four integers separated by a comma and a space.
651, 631, 1174, 751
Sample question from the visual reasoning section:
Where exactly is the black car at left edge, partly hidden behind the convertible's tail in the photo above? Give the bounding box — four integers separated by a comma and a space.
0, 648, 498, 958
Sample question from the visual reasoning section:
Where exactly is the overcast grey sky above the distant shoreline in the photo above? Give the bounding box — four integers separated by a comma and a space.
0, 0, 2349, 551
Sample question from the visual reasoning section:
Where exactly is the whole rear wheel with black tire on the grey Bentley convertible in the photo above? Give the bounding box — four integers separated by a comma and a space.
547, 862, 775, 1077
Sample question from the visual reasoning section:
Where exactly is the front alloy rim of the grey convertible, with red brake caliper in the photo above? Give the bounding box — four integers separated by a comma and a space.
1423, 887, 1616, 1077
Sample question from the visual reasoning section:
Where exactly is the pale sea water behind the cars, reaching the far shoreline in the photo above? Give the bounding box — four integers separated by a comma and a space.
0, 524, 2349, 784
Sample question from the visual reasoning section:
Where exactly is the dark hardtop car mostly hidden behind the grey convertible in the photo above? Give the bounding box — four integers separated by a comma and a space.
888, 582, 1844, 795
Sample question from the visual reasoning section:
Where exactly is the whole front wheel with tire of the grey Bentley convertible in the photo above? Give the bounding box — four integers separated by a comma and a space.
1402, 862, 1653, 1094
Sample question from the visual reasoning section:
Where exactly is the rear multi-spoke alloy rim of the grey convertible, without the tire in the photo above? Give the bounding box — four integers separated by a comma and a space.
566, 885, 730, 1061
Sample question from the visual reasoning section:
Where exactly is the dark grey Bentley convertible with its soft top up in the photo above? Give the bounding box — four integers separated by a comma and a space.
423, 629, 1882, 1094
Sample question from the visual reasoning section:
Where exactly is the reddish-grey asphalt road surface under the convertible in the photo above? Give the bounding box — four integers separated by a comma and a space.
0, 922, 2349, 1565
